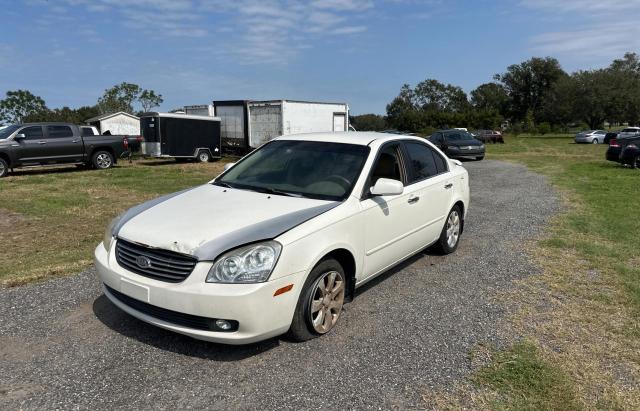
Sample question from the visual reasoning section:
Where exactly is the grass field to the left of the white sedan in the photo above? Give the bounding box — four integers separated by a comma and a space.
0, 160, 230, 285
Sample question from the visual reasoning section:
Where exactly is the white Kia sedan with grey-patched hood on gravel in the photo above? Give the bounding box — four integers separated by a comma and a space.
95, 132, 469, 344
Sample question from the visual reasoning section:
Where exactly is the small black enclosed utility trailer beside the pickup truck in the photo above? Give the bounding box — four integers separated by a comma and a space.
140, 112, 222, 162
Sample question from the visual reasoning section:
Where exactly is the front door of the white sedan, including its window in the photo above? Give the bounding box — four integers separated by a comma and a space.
360, 143, 415, 279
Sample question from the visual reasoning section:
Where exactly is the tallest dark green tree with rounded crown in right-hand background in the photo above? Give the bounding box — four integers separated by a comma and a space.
494, 57, 567, 122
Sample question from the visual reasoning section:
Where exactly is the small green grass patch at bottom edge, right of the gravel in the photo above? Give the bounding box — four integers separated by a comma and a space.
472, 341, 580, 411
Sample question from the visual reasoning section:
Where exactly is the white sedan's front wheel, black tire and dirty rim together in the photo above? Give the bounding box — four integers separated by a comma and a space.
287, 258, 347, 342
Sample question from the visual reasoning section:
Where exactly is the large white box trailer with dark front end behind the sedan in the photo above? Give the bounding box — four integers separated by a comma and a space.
213, 100, 349, 150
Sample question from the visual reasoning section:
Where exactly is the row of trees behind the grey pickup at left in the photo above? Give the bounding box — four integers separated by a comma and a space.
0, 82, 164, 125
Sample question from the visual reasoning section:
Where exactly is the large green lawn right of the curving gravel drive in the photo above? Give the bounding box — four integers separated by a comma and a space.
489, 135, 640, 312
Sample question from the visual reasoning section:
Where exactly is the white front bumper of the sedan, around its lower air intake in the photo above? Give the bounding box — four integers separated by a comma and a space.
95, 242, 306, 344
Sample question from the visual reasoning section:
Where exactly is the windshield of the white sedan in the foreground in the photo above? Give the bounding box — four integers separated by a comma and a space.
213, 140, 369, 201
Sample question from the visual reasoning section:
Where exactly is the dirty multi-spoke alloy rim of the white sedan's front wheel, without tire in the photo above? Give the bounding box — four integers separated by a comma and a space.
309, 271, 345, 334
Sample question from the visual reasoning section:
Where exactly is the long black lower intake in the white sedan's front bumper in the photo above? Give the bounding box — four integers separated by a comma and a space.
104, 284, 239, 332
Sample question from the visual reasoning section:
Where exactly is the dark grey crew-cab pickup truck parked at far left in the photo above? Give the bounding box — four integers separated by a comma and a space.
0, 123, 129, 177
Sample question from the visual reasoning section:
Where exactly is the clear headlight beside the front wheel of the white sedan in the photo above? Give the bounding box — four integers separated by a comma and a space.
207, 241, 282, 284
